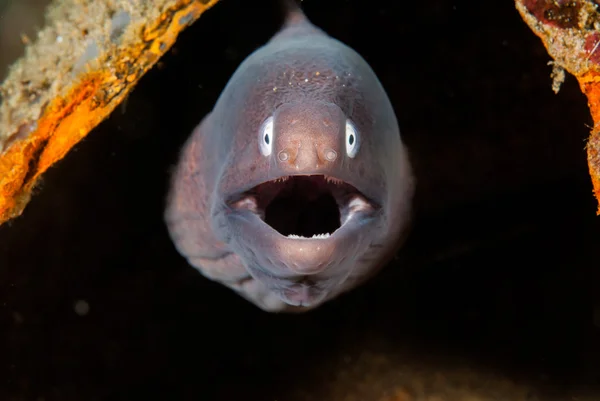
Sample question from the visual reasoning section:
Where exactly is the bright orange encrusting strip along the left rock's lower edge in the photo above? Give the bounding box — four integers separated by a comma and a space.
0, 0, 218, 224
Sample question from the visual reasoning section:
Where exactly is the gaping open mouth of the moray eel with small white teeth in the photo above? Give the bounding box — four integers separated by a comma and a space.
231, 175, 375, 238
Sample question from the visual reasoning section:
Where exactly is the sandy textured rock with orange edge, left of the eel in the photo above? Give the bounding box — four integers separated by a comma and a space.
0, 0, 217, 224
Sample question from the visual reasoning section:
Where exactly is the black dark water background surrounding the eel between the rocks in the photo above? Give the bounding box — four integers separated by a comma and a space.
0, 0, 600, 401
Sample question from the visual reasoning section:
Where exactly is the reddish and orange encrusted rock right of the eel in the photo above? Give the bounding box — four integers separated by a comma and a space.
515, 0, 600, 215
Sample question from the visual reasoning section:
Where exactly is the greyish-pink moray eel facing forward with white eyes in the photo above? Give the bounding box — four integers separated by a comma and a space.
165, 9, 414, 312
